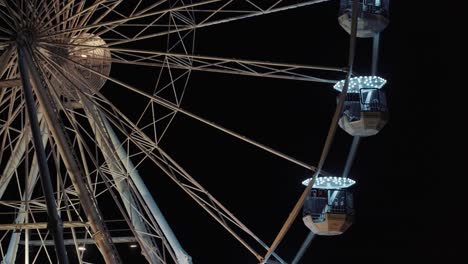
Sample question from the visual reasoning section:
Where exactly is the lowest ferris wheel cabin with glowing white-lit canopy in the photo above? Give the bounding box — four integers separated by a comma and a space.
302, 177, 355, 236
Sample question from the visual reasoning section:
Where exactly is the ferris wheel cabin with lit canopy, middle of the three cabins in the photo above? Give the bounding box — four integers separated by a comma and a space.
334, 76, 388, 137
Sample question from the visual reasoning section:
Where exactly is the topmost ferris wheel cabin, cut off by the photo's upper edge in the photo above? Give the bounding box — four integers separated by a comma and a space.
338, 0, 390, 38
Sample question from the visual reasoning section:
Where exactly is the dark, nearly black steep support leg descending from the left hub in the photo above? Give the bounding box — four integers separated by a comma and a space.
18, 42, 68, 264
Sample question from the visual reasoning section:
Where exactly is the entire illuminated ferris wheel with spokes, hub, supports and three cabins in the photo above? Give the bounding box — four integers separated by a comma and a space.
0, 0, 388, 263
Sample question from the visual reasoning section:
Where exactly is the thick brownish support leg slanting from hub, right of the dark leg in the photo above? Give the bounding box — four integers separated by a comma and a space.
19, 37, 122, 263
